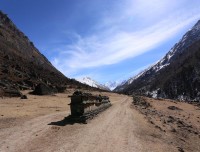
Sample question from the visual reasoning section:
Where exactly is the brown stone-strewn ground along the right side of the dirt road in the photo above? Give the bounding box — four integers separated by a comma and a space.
133, 96, 200, 152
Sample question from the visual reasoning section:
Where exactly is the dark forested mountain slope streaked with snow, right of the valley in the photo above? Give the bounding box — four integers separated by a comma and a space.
115, 21, 200, 101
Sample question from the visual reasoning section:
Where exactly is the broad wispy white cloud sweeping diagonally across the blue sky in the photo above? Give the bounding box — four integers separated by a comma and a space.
52, 0, 200, 78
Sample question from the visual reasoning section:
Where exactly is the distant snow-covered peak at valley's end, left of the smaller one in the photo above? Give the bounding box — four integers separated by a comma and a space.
77, 77, 110, 91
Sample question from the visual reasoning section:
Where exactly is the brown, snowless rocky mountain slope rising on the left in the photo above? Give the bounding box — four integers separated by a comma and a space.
0, 11, 94, 96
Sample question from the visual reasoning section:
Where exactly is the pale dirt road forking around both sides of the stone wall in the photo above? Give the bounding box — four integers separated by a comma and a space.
0, 95, 177, 152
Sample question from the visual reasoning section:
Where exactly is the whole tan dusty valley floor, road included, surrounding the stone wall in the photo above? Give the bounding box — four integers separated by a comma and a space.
0, 90, 200, 152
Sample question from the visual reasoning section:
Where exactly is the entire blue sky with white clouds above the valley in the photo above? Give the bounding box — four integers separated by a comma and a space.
0, 0, 200, 83
